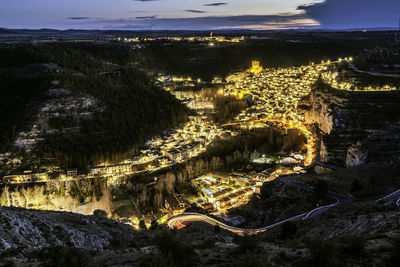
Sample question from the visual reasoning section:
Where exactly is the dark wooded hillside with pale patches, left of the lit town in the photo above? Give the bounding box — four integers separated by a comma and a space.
0, 44, 189, 172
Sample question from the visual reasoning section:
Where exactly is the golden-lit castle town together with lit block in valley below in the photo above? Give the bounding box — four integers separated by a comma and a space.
3, 58, 374, 222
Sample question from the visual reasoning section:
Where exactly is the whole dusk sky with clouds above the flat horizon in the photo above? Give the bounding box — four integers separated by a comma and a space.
0, 0, 400, 30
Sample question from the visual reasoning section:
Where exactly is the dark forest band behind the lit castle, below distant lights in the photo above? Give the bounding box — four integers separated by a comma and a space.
136, 39, 378, 81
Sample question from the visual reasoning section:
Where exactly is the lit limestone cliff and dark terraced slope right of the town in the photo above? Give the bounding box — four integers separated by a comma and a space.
299, 82, 400, 167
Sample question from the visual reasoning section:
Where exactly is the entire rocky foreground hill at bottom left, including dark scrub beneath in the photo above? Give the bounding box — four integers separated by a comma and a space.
0, 207, 155, 266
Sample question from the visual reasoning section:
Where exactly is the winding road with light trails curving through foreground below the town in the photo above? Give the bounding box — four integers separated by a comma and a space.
167, 176, 353, 235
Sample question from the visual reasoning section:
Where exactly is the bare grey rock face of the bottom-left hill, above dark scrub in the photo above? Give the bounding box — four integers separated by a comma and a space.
0, 207, 150, 255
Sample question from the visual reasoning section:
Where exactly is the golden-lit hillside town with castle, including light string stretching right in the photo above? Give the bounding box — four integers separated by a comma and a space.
3, 58, 396, 187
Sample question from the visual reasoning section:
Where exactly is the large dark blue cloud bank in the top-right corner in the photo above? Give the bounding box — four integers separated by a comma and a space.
298, 0, 400, 29
